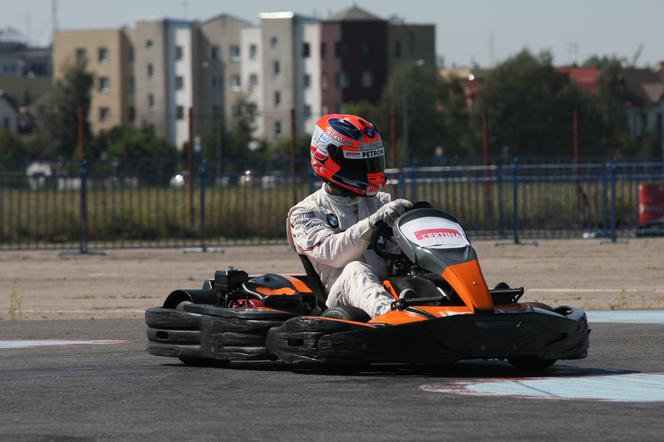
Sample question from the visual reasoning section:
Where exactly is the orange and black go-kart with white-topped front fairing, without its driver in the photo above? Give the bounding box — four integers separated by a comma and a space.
146, 204, 590, 370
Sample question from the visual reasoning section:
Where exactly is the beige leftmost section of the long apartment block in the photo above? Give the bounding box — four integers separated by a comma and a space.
53, 29, 133, 133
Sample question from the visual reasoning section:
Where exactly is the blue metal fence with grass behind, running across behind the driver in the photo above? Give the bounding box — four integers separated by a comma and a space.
0, 160, 664, 251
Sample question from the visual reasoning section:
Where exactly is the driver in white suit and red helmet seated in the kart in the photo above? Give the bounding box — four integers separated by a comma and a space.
288, 114, 413, 317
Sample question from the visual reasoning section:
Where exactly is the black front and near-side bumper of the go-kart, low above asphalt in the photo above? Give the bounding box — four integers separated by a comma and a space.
267, 308, 590, 365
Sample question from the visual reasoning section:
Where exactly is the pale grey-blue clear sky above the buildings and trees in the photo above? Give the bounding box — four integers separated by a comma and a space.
0, 0, 664, 67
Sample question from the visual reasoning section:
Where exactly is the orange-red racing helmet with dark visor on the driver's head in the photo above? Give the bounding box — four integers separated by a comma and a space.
311, 114, 386, 196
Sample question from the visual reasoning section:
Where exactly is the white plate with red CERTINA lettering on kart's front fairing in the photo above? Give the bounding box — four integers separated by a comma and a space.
400, 216, 470, 249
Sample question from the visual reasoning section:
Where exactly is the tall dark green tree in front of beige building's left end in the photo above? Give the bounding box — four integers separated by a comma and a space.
39, 62, 94, 158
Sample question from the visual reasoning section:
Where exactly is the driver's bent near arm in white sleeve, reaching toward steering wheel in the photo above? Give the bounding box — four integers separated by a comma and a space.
289, 209, 374, 268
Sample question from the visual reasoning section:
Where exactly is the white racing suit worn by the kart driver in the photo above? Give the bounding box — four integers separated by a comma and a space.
288, 184, 394, 317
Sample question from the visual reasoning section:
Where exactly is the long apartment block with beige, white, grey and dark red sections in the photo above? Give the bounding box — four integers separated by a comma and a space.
53, 6, 435, 148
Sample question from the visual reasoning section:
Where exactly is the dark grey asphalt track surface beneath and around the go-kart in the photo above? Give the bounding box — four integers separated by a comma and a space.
0, 320, 664, 441
